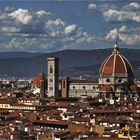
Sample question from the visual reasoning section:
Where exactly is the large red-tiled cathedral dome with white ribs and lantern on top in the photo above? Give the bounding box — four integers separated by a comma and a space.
100, 43, 133, 79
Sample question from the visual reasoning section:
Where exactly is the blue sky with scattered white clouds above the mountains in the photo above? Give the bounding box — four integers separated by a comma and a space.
0, 0, 140, 52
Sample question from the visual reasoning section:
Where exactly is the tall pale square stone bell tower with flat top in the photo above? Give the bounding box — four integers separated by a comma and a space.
48, 57, 59, 98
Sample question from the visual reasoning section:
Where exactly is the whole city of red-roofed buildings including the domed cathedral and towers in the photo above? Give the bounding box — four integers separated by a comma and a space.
0, 42, 140, 140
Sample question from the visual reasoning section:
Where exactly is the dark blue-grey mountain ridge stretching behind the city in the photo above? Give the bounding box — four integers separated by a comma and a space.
0, 48, 140, 77
